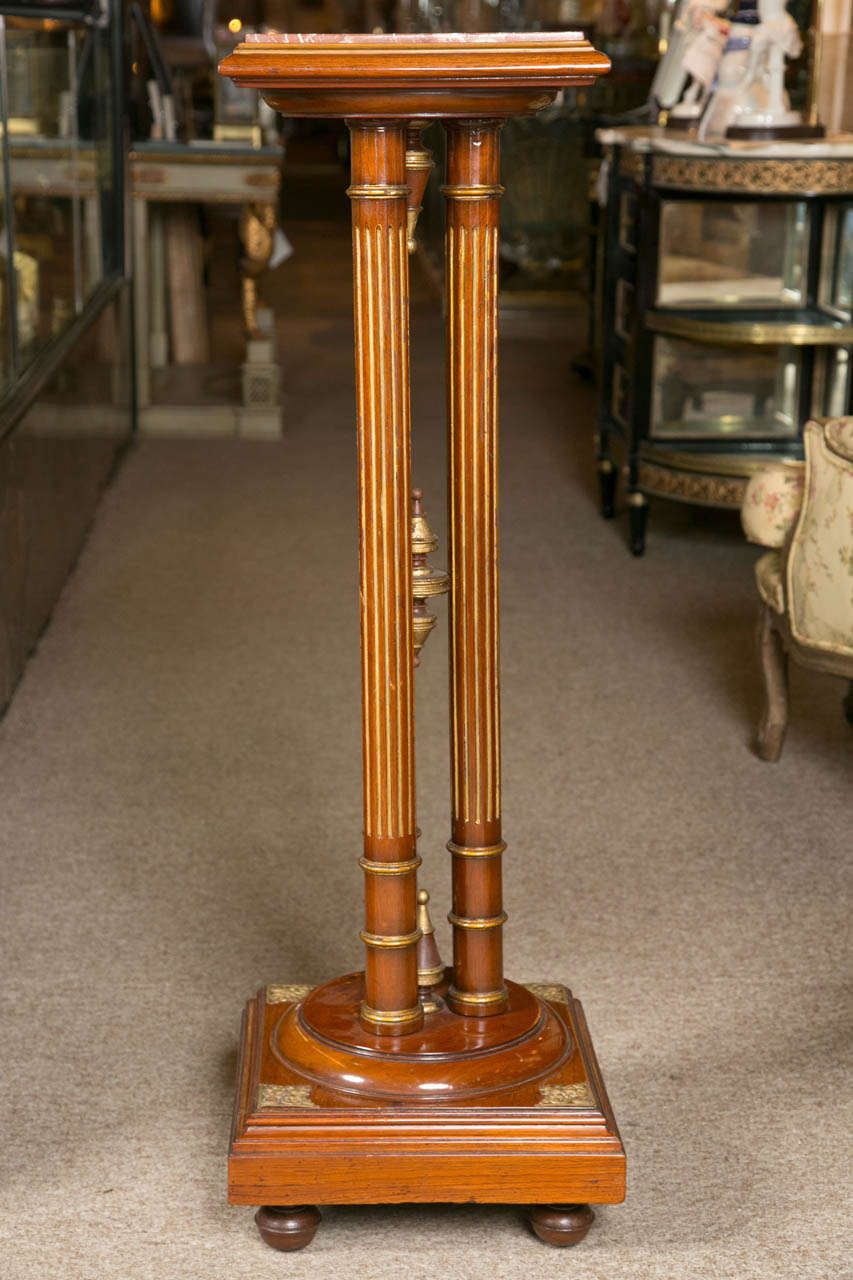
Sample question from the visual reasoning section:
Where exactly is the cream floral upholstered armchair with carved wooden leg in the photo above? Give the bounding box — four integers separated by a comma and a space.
740, 417, 853, 760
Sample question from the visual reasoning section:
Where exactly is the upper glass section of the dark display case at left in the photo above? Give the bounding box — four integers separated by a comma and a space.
0, 5, 120, 388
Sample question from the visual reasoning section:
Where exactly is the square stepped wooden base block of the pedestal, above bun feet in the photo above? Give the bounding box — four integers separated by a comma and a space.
228, 983, 625, 1204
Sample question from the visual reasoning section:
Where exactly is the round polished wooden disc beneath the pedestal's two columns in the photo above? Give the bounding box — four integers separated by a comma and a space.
270, 973, 573, 1106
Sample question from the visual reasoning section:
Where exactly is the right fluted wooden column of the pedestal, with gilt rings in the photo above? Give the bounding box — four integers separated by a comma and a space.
443, 120, 507, 1016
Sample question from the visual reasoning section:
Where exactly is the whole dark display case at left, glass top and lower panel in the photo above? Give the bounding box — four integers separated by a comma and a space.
0, 0, 132, 708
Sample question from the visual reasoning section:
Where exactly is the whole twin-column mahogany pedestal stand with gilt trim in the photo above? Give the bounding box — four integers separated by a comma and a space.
222, 33, 625, 1249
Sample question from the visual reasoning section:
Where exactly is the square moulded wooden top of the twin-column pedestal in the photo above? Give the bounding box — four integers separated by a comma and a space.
219, 31, 610, 119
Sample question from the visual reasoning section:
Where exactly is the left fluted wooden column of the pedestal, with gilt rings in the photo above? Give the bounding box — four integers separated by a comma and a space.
348, 120, 423, 1036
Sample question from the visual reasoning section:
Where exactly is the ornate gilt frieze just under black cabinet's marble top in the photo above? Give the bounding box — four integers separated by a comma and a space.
652, 155, 853, 197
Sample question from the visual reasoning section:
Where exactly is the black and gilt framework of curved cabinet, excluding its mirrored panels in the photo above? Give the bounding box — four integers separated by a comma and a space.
597, 128, 853, 556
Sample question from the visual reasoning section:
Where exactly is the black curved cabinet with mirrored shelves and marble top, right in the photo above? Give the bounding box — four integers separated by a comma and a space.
597, 128, 853, 556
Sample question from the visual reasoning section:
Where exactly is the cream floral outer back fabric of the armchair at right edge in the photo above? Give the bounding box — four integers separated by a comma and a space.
785, 419, 853, 657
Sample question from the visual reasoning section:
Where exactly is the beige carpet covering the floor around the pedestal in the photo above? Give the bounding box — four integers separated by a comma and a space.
0, 275, 853, 1280
